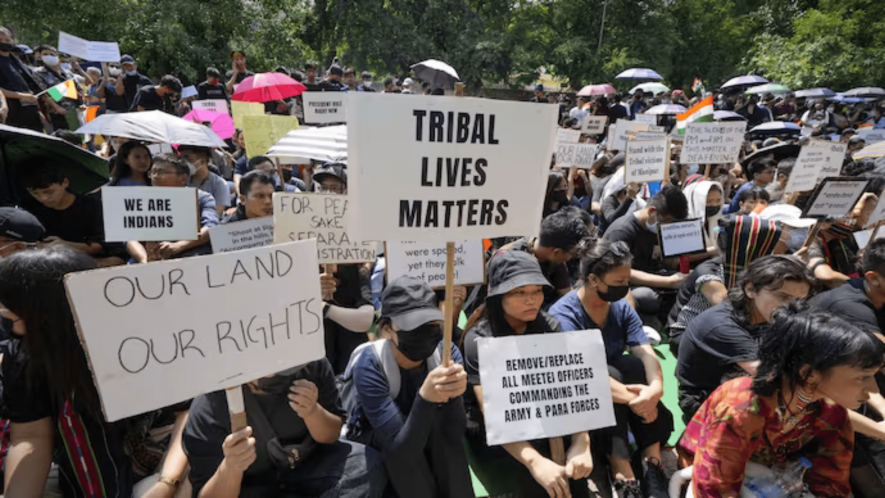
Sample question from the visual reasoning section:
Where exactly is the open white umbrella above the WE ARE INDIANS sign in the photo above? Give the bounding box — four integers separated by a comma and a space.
75, 111, 227, 147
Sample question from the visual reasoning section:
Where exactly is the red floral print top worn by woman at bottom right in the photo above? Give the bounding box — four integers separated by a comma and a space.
678, 377, 854, 497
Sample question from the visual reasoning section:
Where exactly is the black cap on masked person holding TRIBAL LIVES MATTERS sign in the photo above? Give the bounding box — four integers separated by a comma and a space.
381, 275, 443, 331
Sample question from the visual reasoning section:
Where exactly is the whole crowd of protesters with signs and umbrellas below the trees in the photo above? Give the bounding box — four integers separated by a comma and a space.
6, 21, 885, 498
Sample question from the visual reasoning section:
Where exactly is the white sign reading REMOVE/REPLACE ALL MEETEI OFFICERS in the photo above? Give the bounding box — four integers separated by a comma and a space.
478, 330, 615, 446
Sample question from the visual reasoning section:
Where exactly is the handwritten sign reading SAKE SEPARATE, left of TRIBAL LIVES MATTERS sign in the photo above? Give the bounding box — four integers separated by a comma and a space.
273, 192, 377, 264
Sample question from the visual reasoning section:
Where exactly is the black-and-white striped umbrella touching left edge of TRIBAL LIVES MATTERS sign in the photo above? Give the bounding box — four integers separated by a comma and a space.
266, 125, 347, 162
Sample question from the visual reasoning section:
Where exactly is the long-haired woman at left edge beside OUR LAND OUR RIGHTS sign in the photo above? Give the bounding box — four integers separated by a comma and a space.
0, 246, 187, 498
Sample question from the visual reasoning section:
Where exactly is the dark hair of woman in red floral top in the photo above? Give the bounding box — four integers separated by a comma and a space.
752, 302, 885, 396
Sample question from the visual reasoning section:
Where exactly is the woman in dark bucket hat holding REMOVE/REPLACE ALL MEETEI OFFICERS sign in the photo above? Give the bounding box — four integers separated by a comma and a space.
464, 251, 593, 498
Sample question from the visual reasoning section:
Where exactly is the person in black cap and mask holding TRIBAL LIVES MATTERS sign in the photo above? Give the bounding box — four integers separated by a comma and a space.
345, 276, 473, 498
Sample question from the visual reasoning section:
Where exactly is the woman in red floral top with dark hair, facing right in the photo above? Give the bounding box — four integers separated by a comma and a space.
677, 305, 885, 497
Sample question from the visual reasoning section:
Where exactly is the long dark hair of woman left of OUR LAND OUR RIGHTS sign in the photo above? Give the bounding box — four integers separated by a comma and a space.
0, 246, 101, 417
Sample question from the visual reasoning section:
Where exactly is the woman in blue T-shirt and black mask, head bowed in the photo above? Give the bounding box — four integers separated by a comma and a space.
550, 240, 673, 497
